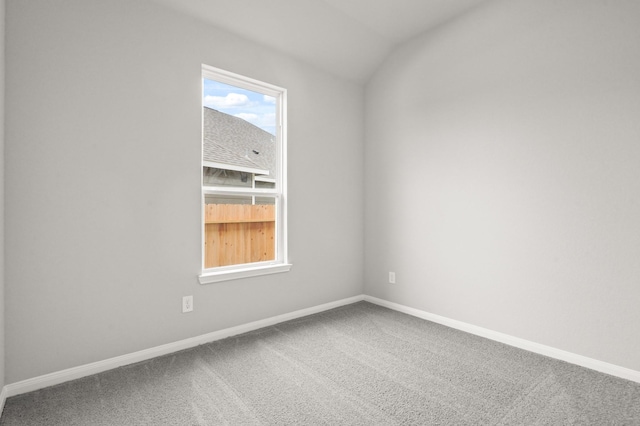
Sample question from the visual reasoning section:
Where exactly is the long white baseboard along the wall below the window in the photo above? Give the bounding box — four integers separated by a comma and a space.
5, 295, 364, 398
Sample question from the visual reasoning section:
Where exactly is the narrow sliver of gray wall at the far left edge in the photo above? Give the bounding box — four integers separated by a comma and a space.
0, 0, 5, 388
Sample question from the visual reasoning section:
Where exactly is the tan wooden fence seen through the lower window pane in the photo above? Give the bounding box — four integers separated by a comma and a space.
204, 204, 276, 268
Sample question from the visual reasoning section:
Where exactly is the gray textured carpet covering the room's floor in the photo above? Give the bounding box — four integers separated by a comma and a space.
0, 302, 640, 426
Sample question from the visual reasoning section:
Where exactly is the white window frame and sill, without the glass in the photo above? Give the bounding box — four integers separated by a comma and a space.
198, 64, 292, 284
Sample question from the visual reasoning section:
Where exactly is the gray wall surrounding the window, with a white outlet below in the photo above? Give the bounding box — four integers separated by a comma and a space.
6, 0, 364, 383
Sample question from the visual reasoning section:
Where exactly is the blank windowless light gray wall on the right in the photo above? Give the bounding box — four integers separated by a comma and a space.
365, 0, 640, 370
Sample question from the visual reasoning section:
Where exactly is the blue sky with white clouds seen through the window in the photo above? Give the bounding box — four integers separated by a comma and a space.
202, 79, 276, 135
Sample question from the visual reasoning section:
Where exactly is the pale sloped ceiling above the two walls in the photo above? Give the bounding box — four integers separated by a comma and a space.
154, 0, 487, 83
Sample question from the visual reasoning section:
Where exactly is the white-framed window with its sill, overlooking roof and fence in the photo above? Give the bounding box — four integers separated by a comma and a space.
199, 65, 291, 284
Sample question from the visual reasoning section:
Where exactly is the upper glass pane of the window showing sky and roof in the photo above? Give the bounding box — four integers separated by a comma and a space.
202, 79, 277, 188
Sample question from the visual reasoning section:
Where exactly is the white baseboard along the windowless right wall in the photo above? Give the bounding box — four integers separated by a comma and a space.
364, 296, 640, 383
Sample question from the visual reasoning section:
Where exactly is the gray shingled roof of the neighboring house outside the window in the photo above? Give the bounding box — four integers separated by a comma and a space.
203, 107, 276, 178
